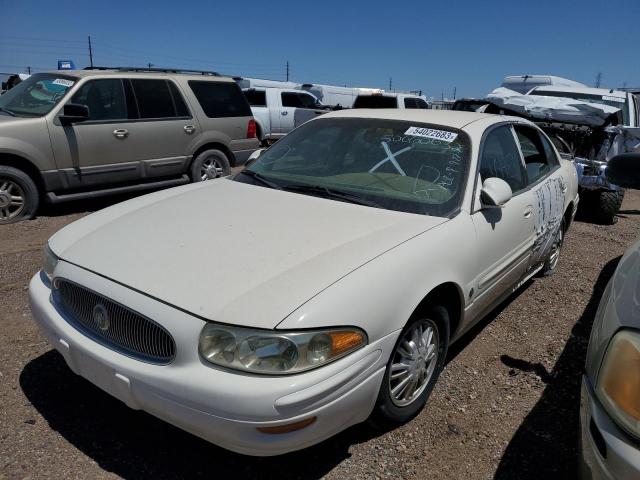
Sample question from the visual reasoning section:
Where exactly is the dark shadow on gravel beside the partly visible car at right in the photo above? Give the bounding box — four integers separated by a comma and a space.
494, 257, 620, 480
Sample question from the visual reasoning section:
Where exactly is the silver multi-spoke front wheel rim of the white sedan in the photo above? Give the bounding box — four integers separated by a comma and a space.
389, 320, 440, 407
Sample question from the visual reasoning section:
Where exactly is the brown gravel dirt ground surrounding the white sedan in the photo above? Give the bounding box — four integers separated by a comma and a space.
0, 192, 640, 479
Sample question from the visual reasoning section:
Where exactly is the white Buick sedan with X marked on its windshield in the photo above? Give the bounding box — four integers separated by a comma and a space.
30, 110, 578, 455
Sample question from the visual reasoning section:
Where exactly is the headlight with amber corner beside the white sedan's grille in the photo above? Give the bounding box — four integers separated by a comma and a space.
199, 323, 367, 375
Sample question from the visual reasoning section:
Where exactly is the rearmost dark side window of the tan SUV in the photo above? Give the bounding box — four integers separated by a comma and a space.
189, 80, 251, 118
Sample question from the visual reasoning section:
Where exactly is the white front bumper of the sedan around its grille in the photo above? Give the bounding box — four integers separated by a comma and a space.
29, 261, 399, 456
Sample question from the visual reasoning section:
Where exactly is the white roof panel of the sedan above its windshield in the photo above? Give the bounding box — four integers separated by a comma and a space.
320, 108, 504, 129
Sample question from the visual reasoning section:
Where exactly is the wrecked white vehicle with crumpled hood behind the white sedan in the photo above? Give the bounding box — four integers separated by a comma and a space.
454, 85, 640, 224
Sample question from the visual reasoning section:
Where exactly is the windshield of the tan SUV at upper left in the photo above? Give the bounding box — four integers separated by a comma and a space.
0, 73, 77, 117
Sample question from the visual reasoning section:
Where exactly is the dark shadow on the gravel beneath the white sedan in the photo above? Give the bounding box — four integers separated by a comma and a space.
20, 282, 531, 480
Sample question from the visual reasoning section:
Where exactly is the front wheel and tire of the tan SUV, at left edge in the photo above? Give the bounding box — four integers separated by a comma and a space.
0, 165, 40, 225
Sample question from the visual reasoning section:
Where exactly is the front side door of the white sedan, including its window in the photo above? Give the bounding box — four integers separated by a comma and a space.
471, 124, 534, 314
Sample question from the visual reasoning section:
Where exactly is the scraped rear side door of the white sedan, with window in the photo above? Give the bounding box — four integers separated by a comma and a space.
514, 125, 567, 270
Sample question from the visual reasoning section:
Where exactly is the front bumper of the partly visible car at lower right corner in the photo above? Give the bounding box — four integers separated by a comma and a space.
580, 376, 640, 480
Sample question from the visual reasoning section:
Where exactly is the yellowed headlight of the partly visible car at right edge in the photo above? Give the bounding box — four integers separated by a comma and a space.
596, 330, 640, 437
